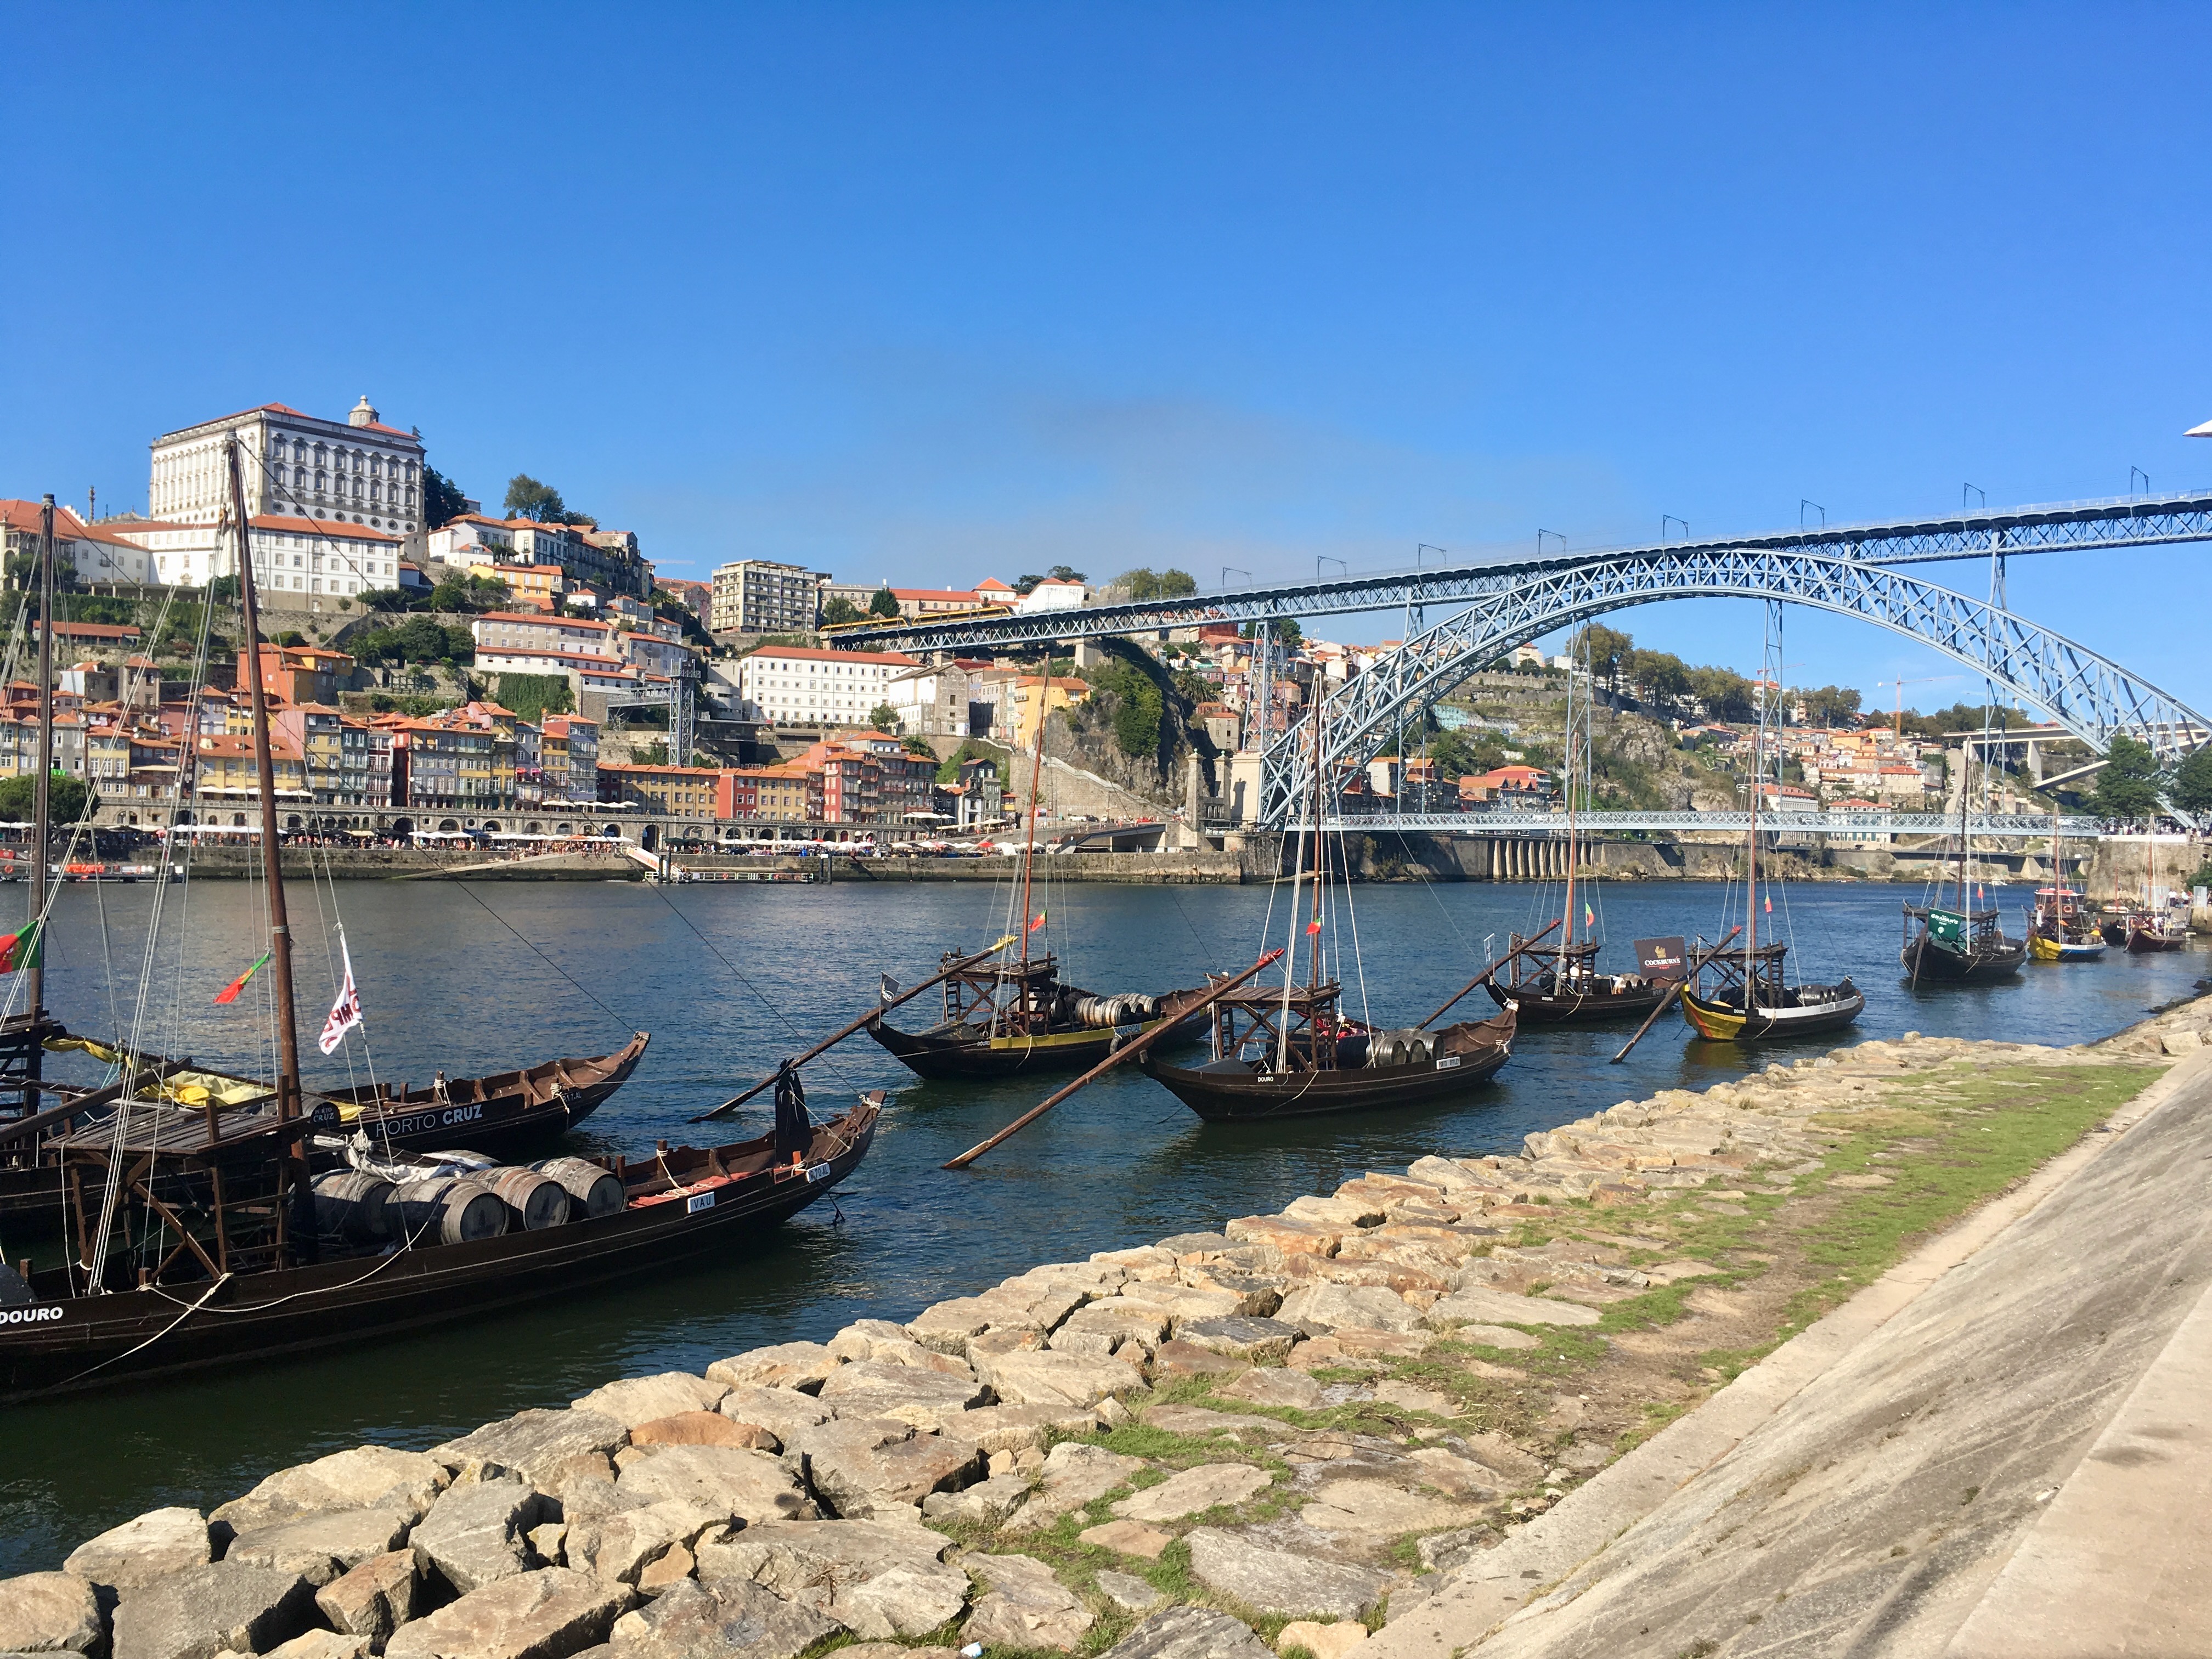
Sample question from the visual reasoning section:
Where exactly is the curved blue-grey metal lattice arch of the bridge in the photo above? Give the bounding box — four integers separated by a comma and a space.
1261, 546, 2212, 825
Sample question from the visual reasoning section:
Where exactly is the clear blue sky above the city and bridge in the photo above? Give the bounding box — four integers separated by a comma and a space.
0, 0, 2212, 708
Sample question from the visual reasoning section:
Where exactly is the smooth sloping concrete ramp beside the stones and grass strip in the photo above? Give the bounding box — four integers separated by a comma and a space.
1361, 1057, 2212, 1659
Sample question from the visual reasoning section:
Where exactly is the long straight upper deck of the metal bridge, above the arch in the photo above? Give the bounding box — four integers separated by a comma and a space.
823, 491, 2212, 650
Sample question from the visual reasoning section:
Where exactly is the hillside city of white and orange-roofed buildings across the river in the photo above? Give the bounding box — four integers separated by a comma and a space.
0, 398, 2150, 836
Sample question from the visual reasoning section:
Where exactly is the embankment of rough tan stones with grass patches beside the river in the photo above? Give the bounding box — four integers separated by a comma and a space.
0, 1002, 2212, 1659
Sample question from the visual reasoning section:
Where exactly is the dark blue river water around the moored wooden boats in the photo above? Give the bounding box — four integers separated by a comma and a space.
0, 881, 2205, 1575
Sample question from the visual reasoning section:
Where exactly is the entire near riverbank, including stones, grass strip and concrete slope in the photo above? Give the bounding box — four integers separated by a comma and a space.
0, 1000, 2212, 1659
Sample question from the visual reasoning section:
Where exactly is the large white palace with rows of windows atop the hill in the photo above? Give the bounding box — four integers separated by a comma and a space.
113, 398, 422, 611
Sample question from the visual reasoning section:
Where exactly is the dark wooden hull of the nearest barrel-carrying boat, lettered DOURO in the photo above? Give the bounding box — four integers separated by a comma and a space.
0, 1104, 878, 1404
